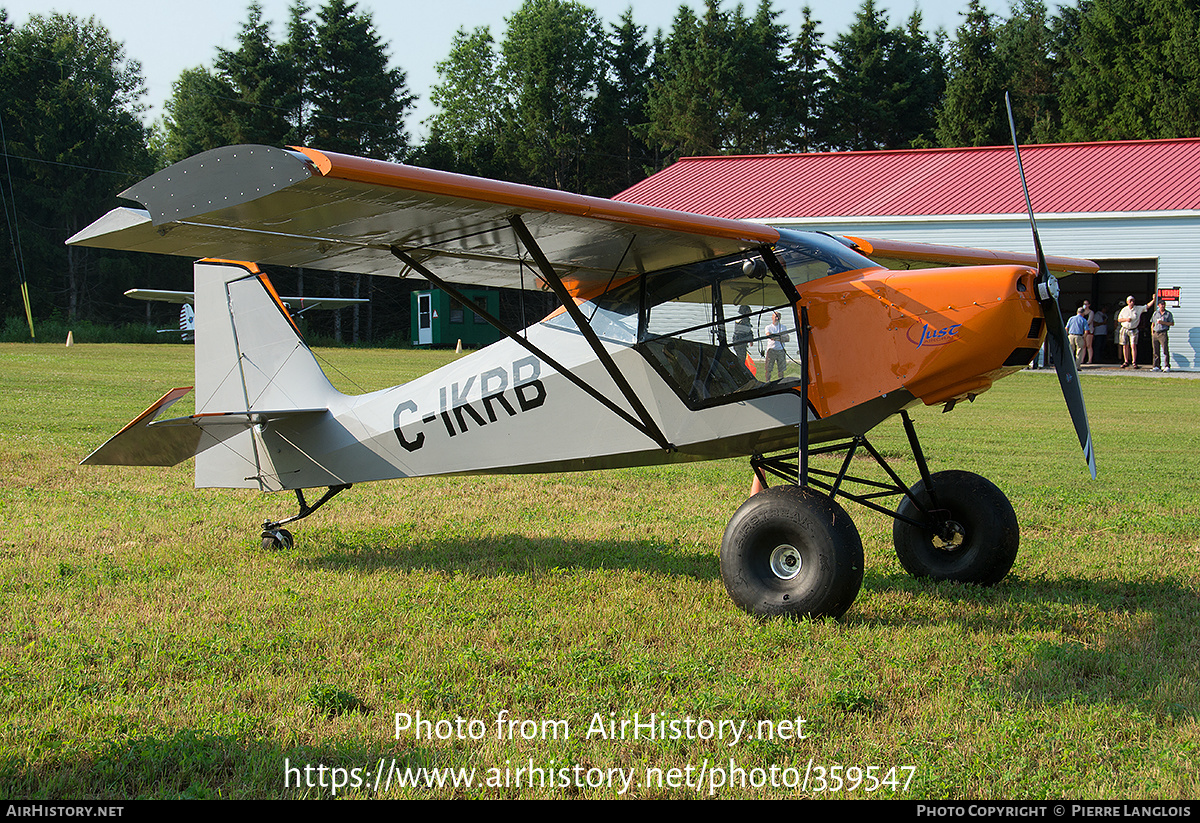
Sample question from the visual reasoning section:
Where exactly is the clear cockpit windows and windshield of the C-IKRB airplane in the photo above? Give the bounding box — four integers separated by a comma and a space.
546, 232, 874, 408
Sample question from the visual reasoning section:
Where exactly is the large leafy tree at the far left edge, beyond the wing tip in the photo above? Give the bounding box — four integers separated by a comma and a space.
0, 14, 152, 319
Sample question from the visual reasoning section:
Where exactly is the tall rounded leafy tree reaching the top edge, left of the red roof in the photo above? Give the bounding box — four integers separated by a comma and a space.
500, 0, 604, 190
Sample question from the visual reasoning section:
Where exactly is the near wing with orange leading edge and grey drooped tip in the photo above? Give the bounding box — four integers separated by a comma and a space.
68, 146, 779, 295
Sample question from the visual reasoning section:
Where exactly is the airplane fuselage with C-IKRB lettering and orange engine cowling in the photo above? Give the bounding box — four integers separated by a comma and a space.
220, 257, 1044, 489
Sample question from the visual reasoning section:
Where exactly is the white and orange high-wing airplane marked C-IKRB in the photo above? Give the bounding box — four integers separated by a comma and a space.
70, 138, 1096, 615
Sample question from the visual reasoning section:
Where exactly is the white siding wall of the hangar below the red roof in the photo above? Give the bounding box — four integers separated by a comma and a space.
757, 212, 1200, 370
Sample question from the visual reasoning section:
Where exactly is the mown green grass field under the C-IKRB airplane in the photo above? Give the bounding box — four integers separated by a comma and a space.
0, 344, 1200, 799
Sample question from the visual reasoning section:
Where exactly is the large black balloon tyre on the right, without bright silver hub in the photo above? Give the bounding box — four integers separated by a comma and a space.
892, 471, 1020, 585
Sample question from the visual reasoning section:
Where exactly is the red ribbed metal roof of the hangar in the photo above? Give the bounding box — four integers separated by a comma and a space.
613, 138, 1200, 221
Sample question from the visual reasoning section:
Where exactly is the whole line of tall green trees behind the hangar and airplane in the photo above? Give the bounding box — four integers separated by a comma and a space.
0, 0, 1200, 338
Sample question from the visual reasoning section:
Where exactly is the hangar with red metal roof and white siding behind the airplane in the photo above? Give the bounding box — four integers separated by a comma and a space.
614, 139, 1200, 370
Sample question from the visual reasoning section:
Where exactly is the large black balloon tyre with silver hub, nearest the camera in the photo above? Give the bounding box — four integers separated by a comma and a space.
721, 486, 863, 618
